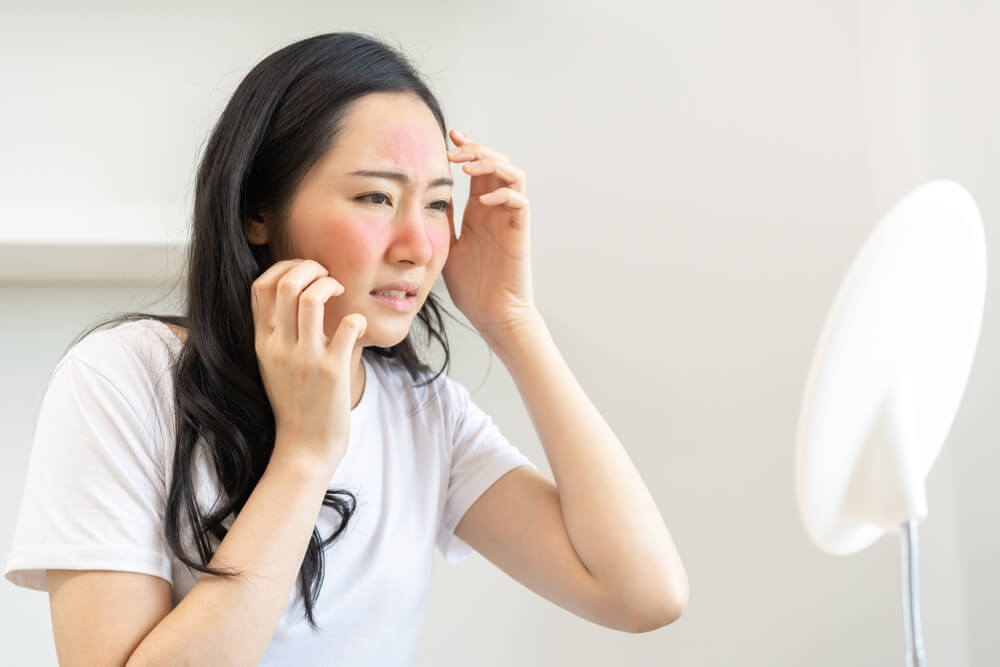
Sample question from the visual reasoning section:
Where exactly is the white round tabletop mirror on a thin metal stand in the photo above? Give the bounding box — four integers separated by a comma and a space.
795, 181, 986, 664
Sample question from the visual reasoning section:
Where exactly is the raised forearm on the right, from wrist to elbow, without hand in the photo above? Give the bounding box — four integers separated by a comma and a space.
491, 316, 688, 614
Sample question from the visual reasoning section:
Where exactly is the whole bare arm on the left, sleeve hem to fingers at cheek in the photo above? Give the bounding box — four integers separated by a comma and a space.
50, 261, 366, 667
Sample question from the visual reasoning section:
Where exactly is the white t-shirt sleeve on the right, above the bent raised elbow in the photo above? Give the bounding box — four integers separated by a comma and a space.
437, 379, 537, 563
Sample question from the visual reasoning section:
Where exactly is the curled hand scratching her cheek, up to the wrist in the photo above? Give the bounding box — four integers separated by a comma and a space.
250, 259, 368, 465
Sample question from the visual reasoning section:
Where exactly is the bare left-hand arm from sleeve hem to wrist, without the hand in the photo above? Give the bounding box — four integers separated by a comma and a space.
47, 448, 340, 667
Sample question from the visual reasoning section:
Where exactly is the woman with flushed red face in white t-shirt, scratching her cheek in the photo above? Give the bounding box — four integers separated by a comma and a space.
6, 34, 688, 665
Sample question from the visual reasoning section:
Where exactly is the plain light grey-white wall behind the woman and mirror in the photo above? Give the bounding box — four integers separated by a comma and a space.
0, 0, 1000, 667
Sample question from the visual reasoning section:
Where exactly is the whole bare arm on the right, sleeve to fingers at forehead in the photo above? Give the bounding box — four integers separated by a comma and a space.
443, 130, 689, 632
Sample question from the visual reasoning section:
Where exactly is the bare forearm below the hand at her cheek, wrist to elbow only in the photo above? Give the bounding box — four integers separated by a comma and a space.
128, 444, 336, 666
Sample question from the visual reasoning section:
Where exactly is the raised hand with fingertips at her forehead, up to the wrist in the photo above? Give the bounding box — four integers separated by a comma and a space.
442, 130, 537, 345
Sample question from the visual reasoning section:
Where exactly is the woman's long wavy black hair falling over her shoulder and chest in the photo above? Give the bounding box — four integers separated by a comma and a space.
74, 33, 450, 631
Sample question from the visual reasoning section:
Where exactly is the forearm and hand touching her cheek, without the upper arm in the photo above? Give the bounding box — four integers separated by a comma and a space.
129, 260, 366, 665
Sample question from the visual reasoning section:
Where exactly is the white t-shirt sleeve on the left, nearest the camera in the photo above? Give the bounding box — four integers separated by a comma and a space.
4, 334, 171, 590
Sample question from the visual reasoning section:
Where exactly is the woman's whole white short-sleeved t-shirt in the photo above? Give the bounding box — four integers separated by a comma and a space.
4, 320, 535, 667
